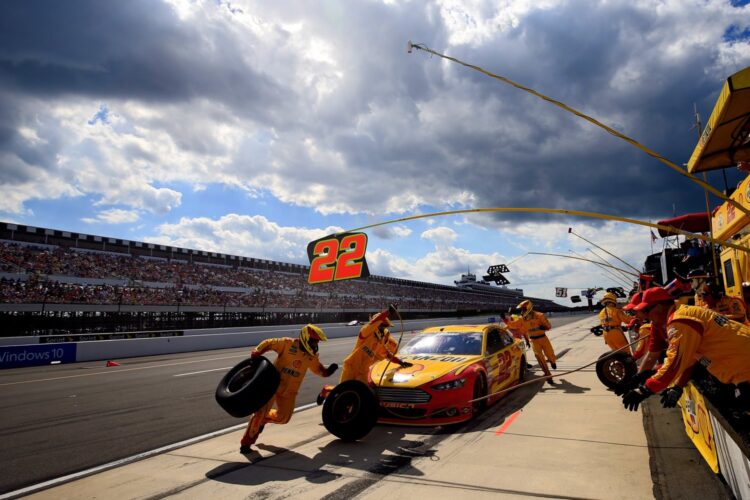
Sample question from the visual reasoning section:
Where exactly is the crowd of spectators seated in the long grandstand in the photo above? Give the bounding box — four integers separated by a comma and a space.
0, 242, 532, 310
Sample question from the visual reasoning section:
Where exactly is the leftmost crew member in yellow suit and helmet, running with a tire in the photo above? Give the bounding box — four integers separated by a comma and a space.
240, 325, 338, 453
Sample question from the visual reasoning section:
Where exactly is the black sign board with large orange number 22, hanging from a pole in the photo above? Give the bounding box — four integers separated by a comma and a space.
307, 233, 370, 284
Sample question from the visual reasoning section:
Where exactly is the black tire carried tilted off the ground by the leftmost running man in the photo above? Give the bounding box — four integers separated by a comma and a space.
216, 356, 281, 418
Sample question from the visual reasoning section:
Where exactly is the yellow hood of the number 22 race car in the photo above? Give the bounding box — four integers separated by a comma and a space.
370, 354, 482, 388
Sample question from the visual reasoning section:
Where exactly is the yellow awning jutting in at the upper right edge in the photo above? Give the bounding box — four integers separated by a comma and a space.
688, 67, 750, 174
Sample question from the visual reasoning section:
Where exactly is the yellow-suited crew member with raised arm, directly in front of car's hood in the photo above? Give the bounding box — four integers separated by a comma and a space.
339, 304, 412, 384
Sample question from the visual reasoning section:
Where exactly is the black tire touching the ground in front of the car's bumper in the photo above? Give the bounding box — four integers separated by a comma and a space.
323, 380, 379, 441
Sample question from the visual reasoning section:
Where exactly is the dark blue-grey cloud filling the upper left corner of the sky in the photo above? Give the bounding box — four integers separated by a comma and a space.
0, 0, 282, 118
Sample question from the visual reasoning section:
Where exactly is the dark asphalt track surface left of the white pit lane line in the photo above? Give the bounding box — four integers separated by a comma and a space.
0, 315, 581, 494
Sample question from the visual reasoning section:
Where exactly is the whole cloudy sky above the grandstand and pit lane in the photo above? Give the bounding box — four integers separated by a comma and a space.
0, 0, 750, 304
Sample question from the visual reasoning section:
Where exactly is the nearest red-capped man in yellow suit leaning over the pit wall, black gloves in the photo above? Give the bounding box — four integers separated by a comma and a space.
622, 287, 750, 411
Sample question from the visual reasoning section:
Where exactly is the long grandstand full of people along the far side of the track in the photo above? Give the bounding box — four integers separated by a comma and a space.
0, 223, 567, 336
